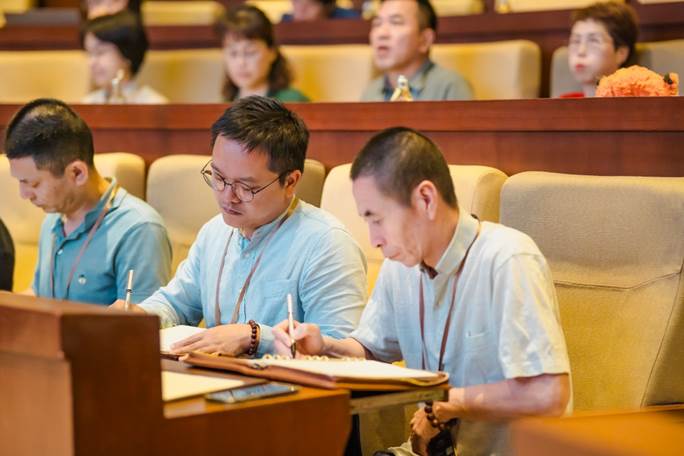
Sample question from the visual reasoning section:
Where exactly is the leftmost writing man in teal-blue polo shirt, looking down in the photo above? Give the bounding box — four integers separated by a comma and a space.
5, 99, 171, 305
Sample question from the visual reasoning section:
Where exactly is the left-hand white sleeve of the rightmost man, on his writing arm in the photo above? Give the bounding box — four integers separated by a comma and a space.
350, 260, 402, 362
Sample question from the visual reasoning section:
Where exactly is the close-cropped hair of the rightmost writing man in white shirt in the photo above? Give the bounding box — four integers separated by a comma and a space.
351, 127, 458, 209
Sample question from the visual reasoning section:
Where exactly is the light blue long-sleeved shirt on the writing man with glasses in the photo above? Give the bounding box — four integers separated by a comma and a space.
141, 201, 367, 355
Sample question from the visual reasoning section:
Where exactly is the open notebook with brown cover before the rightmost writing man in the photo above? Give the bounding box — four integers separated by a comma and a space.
181, 352, 449, 390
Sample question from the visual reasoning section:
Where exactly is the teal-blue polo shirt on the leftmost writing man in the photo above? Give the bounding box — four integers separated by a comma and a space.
33, 179, 171, 305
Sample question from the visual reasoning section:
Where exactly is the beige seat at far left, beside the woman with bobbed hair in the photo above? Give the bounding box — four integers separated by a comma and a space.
0, 50, 89, 103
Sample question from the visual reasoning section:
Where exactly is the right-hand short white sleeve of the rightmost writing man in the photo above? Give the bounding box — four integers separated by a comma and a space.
494, 254, 570, 378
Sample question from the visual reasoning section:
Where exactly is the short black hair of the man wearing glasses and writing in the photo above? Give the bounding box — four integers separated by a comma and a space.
211, 96, 309, 185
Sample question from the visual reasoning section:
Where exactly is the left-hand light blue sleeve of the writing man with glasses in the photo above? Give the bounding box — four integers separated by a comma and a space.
140, 225, 207, 328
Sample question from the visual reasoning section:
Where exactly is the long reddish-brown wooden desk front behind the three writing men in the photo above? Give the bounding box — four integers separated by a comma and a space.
0, 97, 684, 176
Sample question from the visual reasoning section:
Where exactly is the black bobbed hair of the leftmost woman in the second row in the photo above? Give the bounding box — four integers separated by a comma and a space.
81, 10, 149, 76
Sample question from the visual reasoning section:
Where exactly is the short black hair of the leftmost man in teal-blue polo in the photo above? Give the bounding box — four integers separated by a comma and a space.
5, 98, 94, 177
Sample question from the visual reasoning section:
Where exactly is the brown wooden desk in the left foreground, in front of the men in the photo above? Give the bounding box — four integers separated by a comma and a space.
0, 293, 350, 456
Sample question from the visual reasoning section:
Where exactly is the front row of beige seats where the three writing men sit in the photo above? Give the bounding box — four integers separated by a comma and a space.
0, 153, 684, 416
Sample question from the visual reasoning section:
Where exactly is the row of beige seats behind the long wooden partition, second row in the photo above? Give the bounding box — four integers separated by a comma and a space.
0, 40, 684, 103
